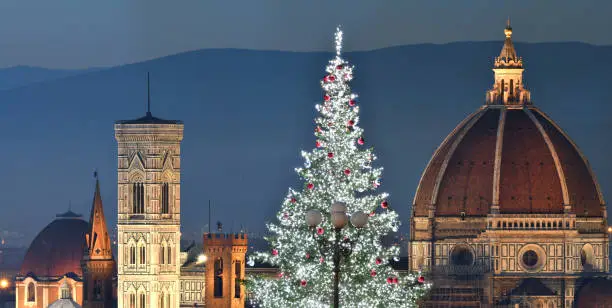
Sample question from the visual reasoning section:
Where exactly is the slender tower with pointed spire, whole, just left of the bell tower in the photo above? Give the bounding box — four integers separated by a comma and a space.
81, 172, 116, 308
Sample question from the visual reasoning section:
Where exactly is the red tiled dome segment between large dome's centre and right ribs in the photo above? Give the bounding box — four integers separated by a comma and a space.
499, 110, 563, 214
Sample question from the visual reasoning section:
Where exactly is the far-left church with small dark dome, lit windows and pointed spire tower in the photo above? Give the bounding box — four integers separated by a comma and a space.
15, 178, 115, 308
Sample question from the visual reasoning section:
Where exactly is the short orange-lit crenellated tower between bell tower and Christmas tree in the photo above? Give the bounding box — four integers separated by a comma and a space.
204, 233, 248, 308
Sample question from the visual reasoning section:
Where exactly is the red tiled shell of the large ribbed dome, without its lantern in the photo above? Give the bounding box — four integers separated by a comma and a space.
413, 105, 604, 217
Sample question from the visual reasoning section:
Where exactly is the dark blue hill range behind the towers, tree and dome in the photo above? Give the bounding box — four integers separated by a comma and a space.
0, 42, 612, 248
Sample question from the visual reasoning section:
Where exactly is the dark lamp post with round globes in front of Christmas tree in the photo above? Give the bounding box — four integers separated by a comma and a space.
306, 202, 368, 308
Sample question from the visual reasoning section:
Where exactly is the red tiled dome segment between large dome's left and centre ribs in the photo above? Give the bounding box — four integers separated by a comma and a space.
436, 108, 500, 216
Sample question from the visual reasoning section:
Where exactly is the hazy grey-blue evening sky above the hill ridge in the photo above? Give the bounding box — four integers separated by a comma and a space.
0, 0, 612, 68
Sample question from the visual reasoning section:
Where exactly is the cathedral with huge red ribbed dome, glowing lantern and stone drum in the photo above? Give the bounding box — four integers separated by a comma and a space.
408, 23, 609, 308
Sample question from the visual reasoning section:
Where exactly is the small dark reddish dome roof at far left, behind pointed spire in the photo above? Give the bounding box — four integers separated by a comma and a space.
20, 211, 89, 277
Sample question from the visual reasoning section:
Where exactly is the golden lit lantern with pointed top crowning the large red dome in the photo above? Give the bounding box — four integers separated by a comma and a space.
486, 19, 531, 106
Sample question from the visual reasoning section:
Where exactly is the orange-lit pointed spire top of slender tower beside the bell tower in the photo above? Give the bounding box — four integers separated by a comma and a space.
86, 176, 113, 260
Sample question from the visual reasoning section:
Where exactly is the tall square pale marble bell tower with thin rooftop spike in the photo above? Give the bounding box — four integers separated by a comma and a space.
115, 73, 183, 308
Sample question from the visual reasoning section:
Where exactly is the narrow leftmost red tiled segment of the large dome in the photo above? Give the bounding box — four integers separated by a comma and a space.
413, 110, 482, 217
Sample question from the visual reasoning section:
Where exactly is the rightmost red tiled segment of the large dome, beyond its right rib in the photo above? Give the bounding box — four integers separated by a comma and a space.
532, 108, 605, 217
